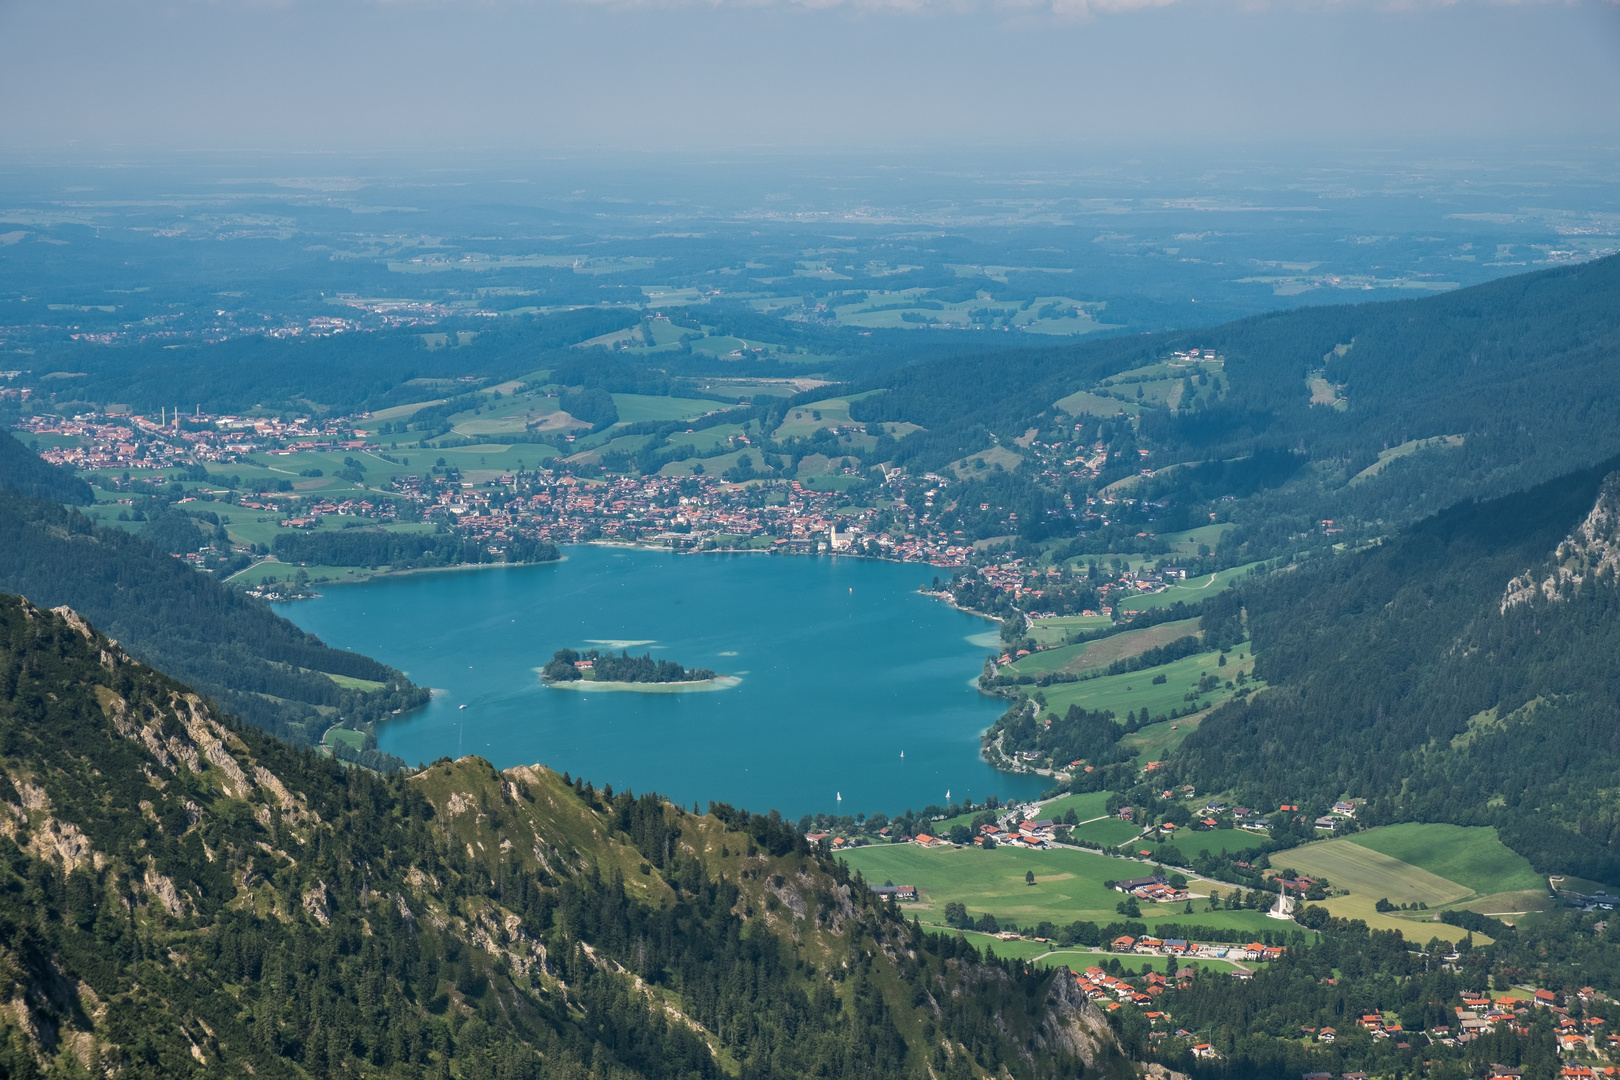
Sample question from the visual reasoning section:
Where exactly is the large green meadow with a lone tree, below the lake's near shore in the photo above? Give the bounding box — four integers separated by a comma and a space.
844, 844, 1278, 931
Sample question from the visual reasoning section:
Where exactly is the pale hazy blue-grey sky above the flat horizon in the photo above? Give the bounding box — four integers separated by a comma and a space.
0, 0, 1620, 152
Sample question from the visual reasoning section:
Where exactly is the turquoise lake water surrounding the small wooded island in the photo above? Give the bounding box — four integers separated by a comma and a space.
279, 546, 1043, 818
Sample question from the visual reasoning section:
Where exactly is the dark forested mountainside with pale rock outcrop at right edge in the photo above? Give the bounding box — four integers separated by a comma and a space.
1171, 458, 1620, 881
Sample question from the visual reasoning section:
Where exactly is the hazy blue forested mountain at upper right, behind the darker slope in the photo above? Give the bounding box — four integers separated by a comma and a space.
851, 256, 1620, 555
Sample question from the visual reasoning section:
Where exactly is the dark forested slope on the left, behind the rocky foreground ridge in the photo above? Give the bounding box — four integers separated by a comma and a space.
0, 488, 428, 751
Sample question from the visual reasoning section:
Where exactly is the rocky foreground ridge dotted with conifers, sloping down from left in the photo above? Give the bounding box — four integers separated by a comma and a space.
0, 597, 1136, 1080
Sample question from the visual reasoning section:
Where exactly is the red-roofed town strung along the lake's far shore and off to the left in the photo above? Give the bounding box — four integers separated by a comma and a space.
18, 406, 1218, 586
